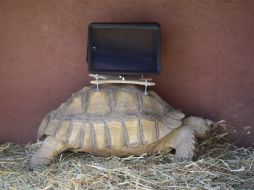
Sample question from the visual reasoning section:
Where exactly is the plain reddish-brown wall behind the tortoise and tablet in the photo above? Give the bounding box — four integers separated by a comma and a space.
0, 0, 254, 145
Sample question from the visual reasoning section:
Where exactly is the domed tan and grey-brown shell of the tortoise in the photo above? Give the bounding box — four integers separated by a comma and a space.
38, 85, 185, 155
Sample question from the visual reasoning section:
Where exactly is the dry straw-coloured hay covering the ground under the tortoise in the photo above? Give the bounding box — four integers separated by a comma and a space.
0, 131, 254, 190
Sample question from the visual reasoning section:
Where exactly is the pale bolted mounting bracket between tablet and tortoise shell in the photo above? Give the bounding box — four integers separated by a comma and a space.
89, 74, 155, 95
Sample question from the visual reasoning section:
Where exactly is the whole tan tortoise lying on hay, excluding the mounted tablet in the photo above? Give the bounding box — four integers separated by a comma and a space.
29, 84, 213, 169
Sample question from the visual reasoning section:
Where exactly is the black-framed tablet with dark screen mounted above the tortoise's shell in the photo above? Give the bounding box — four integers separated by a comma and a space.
88, 23, 160, 74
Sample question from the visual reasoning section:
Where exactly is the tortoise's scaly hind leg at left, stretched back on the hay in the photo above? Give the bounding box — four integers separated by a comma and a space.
28, 136, 68, 170
